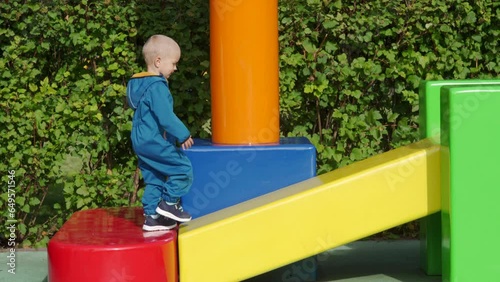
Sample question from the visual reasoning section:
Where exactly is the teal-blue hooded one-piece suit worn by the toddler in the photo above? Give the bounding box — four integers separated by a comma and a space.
127, 72, 193, 215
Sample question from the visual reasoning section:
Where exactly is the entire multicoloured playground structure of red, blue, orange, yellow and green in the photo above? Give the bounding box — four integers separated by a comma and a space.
48, 0, 500, 282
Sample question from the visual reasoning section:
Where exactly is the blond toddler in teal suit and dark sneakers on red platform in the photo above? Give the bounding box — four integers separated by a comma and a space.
127, 35, 193, 231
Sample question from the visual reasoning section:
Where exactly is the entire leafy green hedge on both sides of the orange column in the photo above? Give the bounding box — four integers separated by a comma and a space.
0, 0, 500, 247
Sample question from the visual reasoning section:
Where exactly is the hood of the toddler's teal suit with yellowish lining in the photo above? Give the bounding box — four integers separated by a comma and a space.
127, 72, 168, 111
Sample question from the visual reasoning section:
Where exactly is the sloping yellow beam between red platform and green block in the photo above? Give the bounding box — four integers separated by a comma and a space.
178, 140, 441, 282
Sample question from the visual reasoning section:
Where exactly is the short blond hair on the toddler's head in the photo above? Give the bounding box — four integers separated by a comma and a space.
142, 34, 180, 66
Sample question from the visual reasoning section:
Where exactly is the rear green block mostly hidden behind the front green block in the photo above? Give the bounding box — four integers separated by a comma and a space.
419, 80, 500, 275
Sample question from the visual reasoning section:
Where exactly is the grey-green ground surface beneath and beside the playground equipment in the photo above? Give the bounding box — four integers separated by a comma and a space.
0, 240, 441, 282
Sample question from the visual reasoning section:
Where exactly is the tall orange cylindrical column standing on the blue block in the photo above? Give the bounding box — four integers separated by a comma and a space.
210, 0, 279, 145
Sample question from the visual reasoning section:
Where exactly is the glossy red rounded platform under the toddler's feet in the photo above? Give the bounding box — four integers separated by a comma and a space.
47, 207, 178, 282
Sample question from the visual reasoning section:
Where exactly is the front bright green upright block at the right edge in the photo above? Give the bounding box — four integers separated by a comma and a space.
441, 86, 500, 282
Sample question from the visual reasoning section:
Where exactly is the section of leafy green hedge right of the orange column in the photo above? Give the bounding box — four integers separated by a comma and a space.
279, 0, 500, 173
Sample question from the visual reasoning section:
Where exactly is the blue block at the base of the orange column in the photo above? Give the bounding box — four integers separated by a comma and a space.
182, 137, 316, 218
